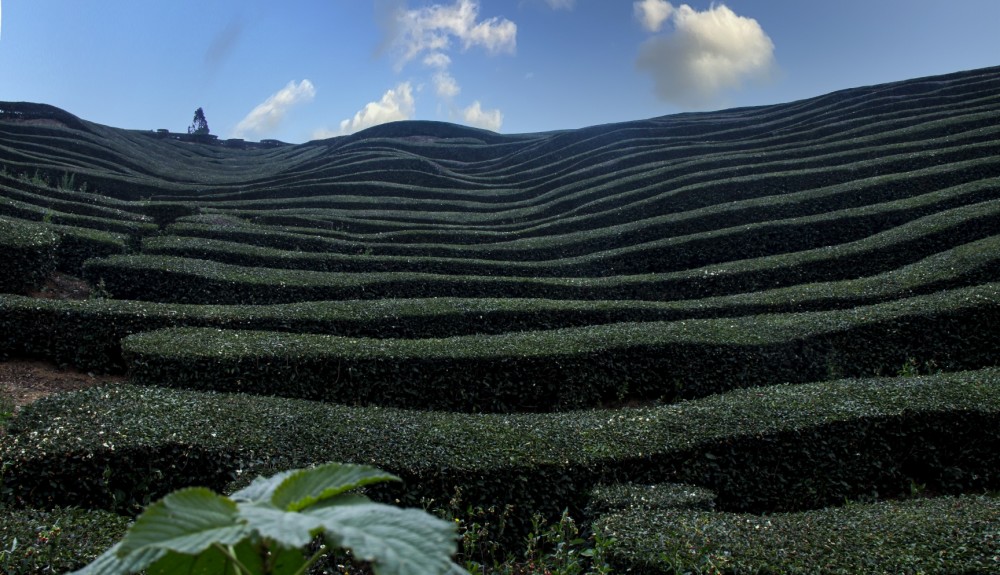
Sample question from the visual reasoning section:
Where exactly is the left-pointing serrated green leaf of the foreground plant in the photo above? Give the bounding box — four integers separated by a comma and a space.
118, 487, 249, 557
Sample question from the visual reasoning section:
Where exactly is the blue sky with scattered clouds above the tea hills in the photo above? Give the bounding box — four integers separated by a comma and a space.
0, 0, 1000, 142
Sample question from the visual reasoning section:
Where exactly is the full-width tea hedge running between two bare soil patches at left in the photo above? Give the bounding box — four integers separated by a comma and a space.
0, 236, 1000, 372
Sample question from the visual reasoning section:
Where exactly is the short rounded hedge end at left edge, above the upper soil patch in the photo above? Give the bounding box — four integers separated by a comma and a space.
0, 217, 59, 293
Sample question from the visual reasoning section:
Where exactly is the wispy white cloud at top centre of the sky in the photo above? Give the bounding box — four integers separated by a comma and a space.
391, 0, 517, 68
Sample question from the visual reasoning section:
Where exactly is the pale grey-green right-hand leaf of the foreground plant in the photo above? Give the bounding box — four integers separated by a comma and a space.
302, 503, 464, 575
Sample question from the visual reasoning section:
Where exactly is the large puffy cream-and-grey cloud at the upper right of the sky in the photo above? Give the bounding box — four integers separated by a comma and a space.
634, 0, 775, 108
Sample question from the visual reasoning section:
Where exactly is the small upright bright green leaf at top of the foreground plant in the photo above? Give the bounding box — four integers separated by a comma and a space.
271, 463, 400, 511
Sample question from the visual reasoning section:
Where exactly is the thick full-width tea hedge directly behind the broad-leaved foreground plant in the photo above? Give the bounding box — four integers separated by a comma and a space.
0, 369, 1000, 527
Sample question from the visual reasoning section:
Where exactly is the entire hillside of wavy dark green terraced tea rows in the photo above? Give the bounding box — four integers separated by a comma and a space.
0, 68, 1000, 573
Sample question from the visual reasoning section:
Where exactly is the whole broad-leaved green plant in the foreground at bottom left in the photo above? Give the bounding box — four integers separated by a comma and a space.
74, 463, 466, 575
